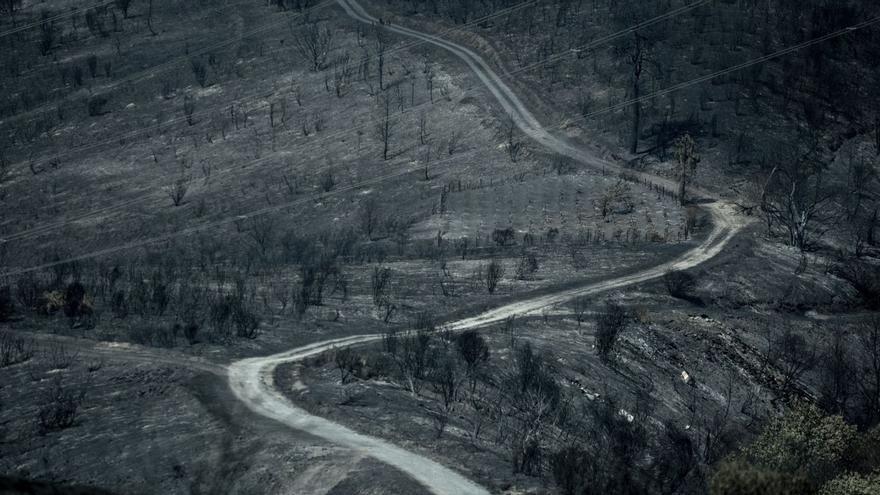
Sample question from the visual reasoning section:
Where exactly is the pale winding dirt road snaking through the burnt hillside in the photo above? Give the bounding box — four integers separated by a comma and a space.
228, 0, 744, 495
